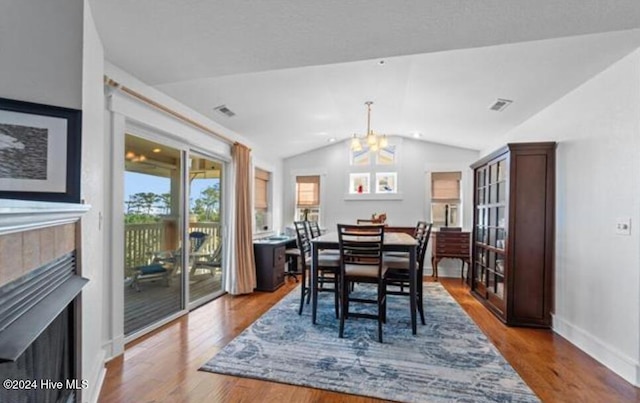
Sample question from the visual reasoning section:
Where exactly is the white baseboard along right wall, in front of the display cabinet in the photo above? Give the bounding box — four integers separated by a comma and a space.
552, 315, 640, 387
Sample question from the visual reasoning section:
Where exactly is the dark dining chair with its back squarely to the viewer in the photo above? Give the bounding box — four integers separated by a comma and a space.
338, 224, 387, 343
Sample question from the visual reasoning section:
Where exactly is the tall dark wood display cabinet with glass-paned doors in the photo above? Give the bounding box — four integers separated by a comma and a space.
471, 142, 556, 327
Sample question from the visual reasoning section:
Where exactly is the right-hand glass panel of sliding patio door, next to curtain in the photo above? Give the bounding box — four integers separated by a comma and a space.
188, 153, 224, 307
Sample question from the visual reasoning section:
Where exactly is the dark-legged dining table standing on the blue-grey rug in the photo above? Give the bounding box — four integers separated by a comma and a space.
311, 232, 418, 334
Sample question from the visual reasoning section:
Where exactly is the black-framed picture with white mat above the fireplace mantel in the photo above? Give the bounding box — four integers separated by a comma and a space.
0, 98, 82, 203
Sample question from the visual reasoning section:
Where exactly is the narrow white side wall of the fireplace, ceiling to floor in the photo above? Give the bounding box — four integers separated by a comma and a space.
81, 0, 105, 402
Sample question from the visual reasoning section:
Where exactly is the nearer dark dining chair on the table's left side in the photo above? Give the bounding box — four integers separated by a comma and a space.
293, 221, 340, 318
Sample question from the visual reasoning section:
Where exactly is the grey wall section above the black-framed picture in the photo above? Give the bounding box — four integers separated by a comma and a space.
0, 0, 82, 109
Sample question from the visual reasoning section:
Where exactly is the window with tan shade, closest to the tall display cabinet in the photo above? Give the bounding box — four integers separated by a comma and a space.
431, 172, 462, 227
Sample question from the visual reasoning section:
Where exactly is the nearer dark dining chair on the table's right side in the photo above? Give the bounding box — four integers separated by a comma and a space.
384, 221, 433, 325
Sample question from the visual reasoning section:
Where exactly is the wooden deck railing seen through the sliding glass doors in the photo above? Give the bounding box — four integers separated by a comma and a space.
124, 222, 222, 269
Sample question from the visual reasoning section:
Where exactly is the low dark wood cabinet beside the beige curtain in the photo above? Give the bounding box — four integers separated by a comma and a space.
253, 237, 295, 291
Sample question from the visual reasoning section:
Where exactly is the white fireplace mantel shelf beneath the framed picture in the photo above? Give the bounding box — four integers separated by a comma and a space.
0, 199, 91, 235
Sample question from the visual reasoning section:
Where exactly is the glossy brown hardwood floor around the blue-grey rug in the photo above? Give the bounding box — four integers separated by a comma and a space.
99, 278, 640, 403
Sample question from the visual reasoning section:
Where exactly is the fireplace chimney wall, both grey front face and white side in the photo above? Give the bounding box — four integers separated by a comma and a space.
0, 0, 104, 401
